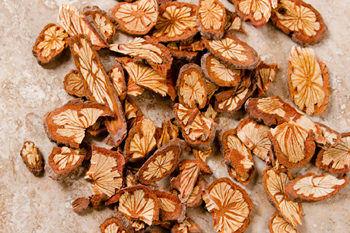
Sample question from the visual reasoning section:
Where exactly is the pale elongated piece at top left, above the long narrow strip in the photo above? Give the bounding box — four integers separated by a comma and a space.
58, 4, 108, 49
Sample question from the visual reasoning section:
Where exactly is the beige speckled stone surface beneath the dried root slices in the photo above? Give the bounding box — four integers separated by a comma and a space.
0, 0, 350, 233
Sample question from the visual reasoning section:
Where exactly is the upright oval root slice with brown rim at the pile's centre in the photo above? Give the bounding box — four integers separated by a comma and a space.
176, 63, 207, 109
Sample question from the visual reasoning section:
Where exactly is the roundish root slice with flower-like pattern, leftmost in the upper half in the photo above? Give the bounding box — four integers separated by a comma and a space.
33, 23, 68, 65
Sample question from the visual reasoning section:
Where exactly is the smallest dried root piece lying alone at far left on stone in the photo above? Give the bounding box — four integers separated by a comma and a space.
20, 141, 44, 176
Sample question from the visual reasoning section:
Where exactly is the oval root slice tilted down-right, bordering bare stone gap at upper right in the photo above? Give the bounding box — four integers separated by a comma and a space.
203, 33, 260, 69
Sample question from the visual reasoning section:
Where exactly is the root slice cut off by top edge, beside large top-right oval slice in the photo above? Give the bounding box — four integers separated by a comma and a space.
230, 0, 272, 28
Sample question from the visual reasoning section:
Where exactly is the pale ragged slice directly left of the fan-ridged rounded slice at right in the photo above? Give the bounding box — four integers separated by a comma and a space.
237, 117, 272, 164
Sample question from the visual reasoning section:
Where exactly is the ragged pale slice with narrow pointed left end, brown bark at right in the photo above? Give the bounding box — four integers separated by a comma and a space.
109, 36, 173, 77
